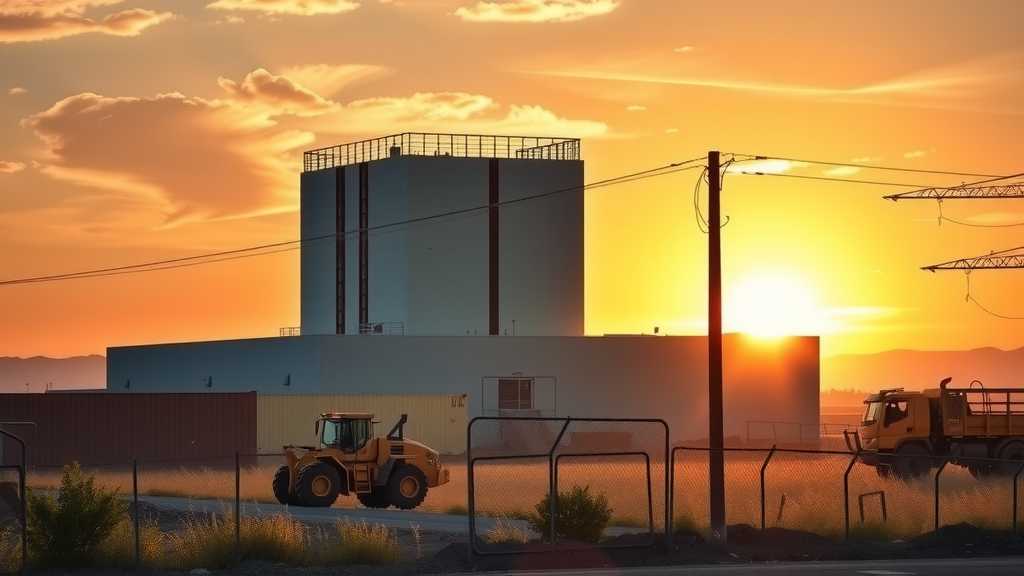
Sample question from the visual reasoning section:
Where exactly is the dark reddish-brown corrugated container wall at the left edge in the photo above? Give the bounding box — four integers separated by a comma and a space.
0, 393, 256, 465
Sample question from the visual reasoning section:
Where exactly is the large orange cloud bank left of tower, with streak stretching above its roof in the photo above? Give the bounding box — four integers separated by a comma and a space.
23, 69, 607, 227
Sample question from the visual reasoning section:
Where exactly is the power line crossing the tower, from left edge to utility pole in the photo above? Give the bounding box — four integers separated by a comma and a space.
0, 157, 705, 287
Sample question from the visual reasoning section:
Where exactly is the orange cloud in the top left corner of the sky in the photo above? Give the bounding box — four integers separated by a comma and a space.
0, 0, 174, 43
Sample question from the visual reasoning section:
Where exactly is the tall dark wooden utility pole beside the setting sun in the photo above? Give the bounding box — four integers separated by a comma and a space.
708, 150, 726, 542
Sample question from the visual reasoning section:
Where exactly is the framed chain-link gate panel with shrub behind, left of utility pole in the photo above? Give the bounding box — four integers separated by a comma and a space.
466, 416, 671, 554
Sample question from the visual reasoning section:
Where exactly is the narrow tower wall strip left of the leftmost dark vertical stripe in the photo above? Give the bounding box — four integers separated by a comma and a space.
299, 168, 337, 334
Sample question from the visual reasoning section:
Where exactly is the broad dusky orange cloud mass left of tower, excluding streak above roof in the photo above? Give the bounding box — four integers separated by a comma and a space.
24, 93, 312, 223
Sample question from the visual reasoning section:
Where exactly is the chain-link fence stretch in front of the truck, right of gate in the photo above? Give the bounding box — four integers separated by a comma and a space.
672, 447, 1024, 539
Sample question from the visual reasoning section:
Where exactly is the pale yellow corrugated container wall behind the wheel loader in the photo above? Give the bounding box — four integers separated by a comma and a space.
257, 395, 467, 454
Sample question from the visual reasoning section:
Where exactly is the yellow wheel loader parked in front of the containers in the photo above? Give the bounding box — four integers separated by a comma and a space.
273, 412, 449, 510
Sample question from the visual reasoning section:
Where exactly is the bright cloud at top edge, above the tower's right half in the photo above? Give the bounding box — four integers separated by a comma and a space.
455, 0, 618, 23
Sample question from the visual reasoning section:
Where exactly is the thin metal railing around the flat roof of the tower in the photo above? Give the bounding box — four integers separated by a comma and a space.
302, 132, 580, 172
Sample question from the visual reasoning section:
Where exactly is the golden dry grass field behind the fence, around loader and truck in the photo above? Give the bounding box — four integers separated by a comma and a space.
29, 452, 1024, 537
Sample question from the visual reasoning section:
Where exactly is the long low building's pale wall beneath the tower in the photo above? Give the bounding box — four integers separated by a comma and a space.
108, 336, 819, 440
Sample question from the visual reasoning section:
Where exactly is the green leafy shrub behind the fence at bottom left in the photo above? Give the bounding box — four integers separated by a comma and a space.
28, 462, 127, 568
